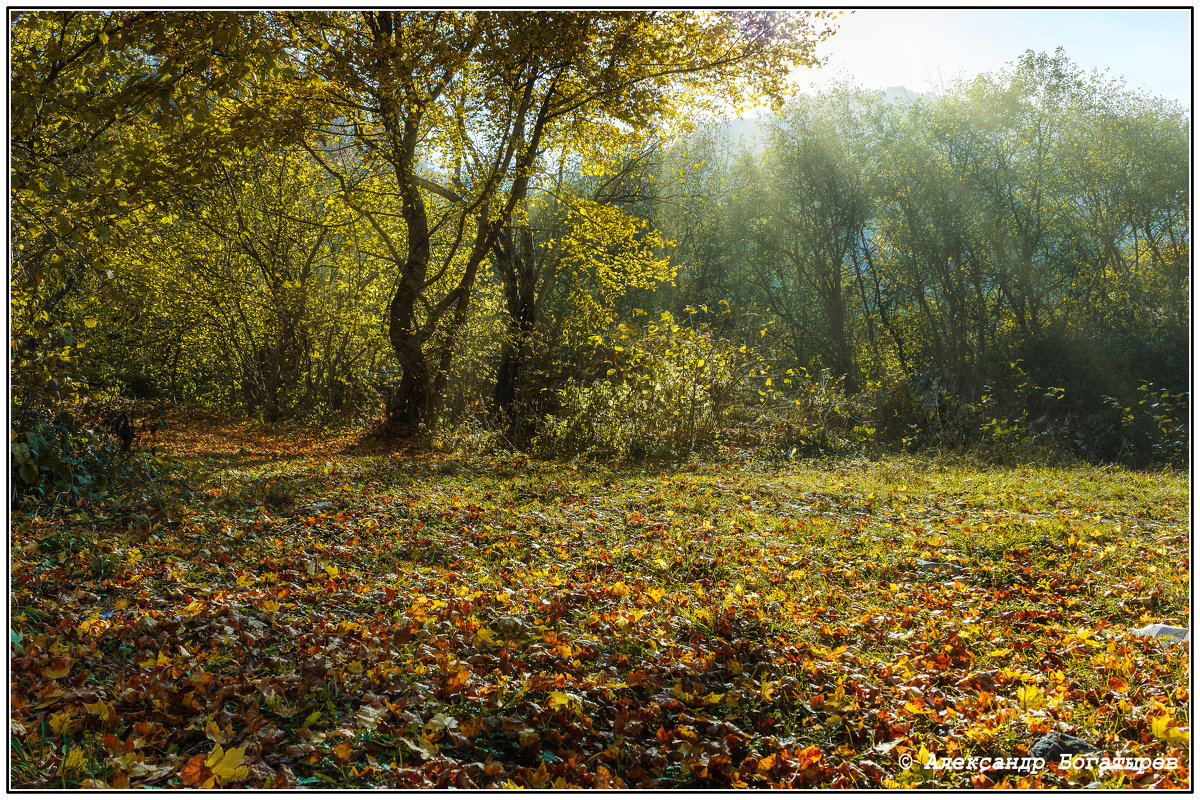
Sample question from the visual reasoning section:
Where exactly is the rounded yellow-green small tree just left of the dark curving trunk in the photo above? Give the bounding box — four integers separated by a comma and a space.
100, 148, 385, 422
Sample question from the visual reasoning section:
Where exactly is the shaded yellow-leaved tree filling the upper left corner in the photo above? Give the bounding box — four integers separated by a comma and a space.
10, 11, 290, 412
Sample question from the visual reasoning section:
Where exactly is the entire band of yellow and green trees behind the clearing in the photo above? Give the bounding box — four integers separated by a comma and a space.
10, 10, 1190, 474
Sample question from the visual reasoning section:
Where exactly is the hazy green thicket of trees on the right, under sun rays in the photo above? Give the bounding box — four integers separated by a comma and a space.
661, 52, 1189, 463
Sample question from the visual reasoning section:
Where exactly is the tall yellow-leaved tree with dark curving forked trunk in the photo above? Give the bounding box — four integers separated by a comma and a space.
290, 11, 835, 431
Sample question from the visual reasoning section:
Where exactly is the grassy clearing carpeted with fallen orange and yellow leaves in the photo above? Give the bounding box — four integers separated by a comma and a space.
10, 420, 1190, 788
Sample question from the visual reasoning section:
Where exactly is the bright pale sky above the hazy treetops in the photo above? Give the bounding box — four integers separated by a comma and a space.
796, 8, 1192, 108
